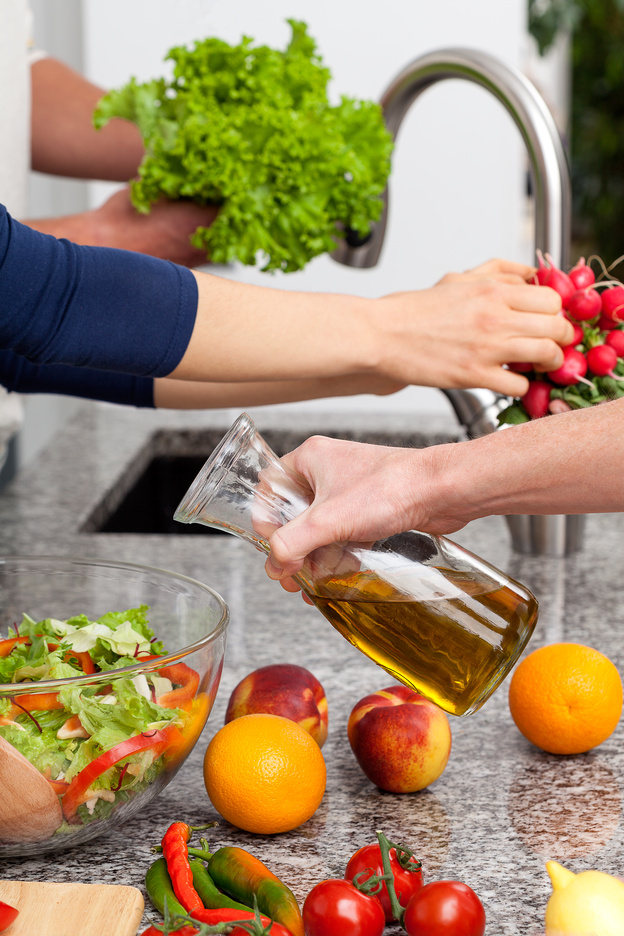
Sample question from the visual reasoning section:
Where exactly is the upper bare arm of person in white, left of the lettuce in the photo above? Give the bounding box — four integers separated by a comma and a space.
31, 58, 143, 179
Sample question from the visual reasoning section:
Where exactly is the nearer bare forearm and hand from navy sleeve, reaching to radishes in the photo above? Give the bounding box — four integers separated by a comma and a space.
169, 261, 572, 396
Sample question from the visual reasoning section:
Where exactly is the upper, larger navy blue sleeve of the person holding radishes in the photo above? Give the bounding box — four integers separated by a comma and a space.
0, 206, 198, 377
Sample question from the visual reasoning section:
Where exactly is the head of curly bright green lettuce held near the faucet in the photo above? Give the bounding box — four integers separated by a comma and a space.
94, 20, 392, 272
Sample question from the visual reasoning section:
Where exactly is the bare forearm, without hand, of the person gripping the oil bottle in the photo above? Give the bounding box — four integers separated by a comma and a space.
428, 400, 624, 522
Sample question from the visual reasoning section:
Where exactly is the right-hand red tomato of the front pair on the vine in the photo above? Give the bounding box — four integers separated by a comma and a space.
403, 881, 485, 936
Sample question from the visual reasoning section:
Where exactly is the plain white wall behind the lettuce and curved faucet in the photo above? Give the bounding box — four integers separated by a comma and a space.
83, 0, 532, 412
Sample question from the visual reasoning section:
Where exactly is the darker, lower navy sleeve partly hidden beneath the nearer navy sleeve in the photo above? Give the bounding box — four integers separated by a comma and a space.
0, 349, 154, 407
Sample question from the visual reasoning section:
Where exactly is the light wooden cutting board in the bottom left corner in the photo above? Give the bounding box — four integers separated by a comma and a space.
0, 881, 144, 936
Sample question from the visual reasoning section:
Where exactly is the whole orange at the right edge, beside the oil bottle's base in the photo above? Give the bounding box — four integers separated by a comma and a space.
509, 643, 622, 754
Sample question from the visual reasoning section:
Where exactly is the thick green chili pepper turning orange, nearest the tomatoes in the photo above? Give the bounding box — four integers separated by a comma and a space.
208, 846, 304, 936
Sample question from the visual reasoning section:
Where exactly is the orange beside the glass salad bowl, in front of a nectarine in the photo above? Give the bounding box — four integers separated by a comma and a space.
204, 714, 326, 835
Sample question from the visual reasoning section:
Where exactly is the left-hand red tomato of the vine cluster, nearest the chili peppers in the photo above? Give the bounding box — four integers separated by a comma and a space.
303, 878, 386, 936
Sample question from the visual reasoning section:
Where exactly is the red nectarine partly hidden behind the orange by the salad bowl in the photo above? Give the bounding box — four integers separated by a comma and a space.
225, 663, 327, 747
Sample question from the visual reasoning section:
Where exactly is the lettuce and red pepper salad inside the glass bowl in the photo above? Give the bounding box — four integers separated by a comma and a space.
0, 605, 209, 832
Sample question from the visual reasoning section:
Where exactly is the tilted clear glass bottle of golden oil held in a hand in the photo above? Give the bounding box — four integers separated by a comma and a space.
175, 413, 537, 715
